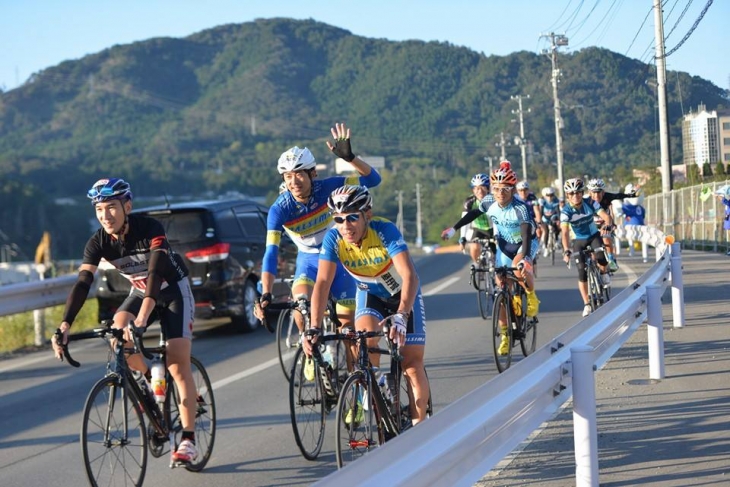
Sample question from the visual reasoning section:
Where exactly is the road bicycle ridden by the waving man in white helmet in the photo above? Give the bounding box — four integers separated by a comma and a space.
264, 294, 347, 460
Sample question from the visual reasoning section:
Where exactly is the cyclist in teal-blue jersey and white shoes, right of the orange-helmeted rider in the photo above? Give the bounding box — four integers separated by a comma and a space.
560, 178, 613, 316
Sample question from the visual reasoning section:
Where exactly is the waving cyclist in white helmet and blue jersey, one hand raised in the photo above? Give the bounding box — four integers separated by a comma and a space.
254, 123, 380, 377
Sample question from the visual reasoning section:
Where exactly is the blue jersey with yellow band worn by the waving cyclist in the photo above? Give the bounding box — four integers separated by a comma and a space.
262, 173, 380, 275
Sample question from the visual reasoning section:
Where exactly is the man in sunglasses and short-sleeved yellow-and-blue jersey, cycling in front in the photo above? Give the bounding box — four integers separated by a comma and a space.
304, 185, 429, 425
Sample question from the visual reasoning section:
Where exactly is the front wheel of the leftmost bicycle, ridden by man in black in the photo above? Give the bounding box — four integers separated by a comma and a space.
80, 375, 147, 486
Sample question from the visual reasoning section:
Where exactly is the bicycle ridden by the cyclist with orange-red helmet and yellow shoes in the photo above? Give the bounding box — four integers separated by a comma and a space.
492, 266, 538, 373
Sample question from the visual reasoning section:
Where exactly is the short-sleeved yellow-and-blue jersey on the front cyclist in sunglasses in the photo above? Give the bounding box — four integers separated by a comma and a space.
319, 217, 408, 299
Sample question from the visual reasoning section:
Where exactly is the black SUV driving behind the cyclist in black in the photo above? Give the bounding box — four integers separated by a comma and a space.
96, 199, 297, 332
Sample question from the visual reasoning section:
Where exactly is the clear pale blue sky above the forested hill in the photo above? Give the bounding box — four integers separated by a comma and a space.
0, 0, 730, 91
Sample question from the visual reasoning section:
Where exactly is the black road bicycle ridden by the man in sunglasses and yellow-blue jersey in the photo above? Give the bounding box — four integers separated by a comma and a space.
335, 318, 433, 468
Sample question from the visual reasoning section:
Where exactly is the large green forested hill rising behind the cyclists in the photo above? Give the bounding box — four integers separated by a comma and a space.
0, 19, 728, 258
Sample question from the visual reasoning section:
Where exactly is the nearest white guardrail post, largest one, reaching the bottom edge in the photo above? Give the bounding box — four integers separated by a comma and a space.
570, 345, 598, 487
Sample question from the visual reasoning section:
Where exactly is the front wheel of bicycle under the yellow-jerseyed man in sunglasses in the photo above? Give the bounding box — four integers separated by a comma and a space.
335, 371, 385, 468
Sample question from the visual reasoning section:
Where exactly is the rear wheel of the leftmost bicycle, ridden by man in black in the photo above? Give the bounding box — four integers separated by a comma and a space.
165, 357, 217, 472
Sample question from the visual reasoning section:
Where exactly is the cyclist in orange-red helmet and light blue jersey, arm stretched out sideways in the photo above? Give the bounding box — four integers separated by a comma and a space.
441, 161, 540, 355
